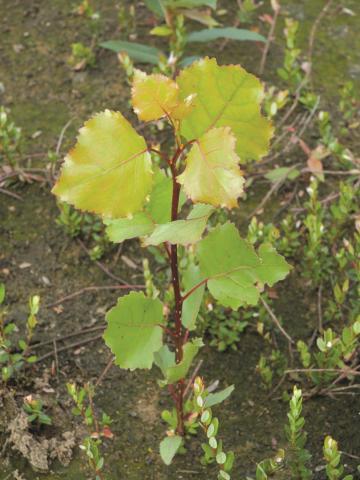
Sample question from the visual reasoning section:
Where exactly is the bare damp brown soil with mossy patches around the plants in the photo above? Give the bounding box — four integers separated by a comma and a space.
0, 0, 360, 480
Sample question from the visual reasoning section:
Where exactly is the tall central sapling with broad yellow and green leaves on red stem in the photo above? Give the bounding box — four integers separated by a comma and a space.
53, 58, 290, 464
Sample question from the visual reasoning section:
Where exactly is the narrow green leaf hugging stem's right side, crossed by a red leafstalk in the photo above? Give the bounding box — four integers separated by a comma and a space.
181, 263, 205, 330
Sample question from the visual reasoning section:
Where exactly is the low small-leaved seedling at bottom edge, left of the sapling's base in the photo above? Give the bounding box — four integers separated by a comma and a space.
67, 383, 113, 480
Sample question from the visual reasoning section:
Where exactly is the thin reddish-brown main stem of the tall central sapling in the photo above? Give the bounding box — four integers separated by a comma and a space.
170, 147, 185, 435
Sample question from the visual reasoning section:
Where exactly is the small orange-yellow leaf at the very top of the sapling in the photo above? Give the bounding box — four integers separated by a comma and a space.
132, 70, 179, 122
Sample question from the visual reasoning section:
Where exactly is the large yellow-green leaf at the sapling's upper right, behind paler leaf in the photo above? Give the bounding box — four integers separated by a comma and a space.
177, 58, 273, 162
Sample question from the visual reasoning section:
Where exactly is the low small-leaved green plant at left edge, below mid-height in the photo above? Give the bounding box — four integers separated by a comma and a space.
0, 283, 40, 383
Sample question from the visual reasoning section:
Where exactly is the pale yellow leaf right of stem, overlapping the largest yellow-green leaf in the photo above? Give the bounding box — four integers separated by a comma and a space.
177, 127, 244, 208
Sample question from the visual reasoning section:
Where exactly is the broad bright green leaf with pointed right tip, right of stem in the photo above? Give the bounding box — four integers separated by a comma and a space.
197, 223, 290, 310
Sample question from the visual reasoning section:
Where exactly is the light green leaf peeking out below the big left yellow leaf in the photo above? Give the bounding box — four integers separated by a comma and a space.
104, 213, 154, 243
